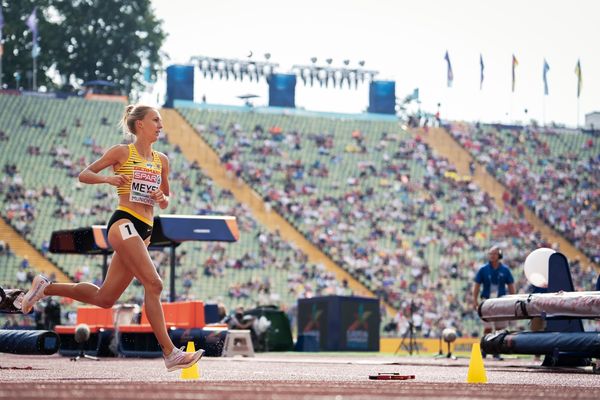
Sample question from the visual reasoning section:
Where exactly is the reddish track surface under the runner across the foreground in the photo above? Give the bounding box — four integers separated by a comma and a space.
0, 353, 600, 400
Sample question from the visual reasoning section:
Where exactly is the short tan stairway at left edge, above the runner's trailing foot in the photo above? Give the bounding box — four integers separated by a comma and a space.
0, 218, 71, 282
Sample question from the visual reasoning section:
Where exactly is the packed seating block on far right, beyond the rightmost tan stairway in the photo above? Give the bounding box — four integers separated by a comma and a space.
449, 123, 600, 263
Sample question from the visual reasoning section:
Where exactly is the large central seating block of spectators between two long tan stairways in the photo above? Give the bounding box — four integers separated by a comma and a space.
179, 108, 584, 334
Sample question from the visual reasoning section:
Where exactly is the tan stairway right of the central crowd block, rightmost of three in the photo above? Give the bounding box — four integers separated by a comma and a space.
411, 128, 600, 269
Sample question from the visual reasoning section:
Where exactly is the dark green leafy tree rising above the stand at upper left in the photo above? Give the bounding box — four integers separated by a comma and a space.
0, 0, 166, 94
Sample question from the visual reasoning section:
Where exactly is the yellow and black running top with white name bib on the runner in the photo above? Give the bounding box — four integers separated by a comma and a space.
115, 143, 162, 206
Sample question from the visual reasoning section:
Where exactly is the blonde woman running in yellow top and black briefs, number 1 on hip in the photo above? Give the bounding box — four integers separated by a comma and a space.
22, 105, 204, 371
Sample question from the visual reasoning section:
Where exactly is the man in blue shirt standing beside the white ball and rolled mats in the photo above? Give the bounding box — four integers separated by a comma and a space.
473, 246, 515, 359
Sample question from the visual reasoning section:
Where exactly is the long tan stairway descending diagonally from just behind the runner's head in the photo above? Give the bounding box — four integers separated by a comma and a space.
161, 109, 396, 315
